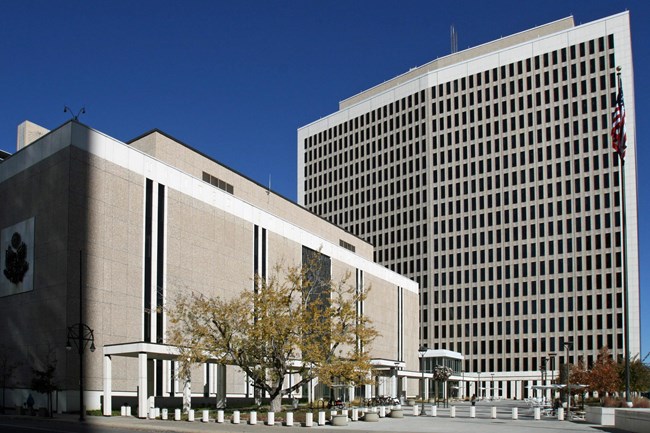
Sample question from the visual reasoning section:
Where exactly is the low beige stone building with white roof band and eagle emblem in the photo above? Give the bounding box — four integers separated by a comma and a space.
0, 120, 420, 416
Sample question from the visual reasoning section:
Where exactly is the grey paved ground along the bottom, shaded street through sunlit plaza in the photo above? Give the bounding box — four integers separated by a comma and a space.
0, 401, 622, 433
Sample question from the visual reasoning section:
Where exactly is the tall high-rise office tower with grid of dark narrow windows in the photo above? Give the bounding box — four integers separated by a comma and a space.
298, 12, 640, 397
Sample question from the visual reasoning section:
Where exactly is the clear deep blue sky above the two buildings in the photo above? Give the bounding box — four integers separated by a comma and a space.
0, 0, 650, 354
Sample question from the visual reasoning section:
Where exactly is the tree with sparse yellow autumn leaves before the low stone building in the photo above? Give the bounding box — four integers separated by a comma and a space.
168, 254, 377, 412
